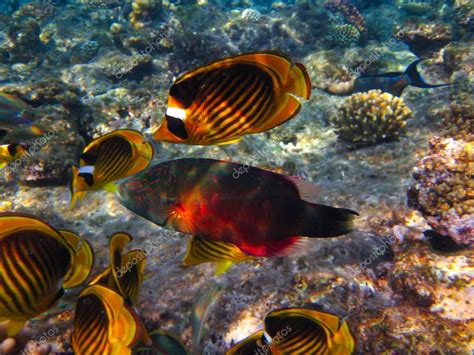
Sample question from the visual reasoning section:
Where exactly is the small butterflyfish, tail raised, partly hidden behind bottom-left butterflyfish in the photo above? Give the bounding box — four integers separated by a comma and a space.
90, 232, 146, 305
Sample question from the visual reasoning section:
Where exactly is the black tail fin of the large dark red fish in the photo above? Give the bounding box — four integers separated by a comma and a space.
305, 203, 359, 238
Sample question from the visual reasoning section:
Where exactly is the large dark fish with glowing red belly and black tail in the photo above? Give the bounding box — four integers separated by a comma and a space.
118, 158, 357, 256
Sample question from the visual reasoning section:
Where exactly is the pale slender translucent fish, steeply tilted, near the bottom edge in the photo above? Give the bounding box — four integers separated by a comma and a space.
191, 284, 224, 354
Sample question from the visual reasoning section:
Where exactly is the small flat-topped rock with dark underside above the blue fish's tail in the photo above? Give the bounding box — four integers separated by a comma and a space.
397, 23, 452, 58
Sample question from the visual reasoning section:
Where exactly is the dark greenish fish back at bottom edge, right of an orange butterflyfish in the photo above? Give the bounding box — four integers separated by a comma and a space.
133, 329, 189, 355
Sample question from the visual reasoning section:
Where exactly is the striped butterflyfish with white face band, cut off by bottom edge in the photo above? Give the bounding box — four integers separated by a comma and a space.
226, 308, 355, 355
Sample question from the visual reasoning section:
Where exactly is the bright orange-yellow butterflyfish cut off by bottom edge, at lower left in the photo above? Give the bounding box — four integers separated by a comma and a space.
72, 285, 146, 355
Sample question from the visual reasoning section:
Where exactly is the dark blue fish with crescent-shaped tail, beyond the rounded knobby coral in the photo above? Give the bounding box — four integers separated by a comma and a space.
327, 58, 451, 96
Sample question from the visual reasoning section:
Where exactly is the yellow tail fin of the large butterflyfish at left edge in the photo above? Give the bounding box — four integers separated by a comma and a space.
63, 240, 94, 288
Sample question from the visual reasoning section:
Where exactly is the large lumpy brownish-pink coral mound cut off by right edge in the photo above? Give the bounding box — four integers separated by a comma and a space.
408, 137, 474, 244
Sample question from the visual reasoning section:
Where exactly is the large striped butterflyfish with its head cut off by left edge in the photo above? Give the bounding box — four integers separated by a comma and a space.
0, 213, 94, 336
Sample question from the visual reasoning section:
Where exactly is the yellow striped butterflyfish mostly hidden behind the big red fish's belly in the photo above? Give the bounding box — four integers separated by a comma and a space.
182, 236, 254, 275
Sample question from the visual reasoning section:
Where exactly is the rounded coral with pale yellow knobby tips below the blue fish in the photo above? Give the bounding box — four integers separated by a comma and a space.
331, 90, 413, 146
